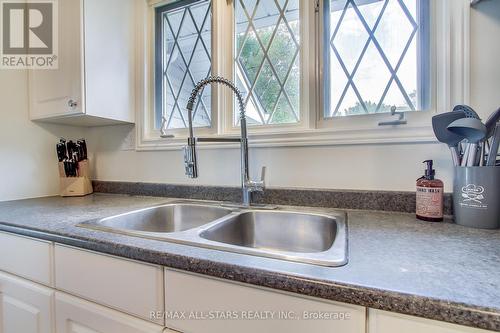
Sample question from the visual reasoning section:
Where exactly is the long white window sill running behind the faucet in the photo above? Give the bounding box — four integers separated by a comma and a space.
136, 126, 437, 151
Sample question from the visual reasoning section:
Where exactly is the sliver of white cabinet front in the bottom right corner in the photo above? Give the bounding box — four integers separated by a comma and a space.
367, 309, 490, 333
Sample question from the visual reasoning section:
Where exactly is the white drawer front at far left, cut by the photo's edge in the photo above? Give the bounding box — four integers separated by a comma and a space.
0, 232, 53, 286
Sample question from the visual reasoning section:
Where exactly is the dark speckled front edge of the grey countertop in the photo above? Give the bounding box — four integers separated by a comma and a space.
0, 223, 500, 331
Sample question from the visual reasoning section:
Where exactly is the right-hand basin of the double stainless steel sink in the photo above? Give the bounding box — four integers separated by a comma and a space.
200, 211, 337, 253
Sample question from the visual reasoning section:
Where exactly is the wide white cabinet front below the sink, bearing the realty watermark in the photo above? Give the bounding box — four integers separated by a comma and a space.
165, 269, 366, 333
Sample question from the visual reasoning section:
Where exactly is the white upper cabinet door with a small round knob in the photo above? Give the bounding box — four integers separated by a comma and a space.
29, 0, 85, 120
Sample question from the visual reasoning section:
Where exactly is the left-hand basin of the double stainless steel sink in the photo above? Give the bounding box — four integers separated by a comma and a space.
81, 203, 232, 233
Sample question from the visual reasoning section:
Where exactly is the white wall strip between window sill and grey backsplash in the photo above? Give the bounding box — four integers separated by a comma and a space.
89, 127, 449, 190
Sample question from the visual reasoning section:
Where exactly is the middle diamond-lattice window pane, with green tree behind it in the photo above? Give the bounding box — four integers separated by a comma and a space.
234, 0, 300, 125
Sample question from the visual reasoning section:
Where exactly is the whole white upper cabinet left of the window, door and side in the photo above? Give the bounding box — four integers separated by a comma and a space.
29, 0, 136, 126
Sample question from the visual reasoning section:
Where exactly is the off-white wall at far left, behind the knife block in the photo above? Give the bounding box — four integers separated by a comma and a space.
0, 70, 84, 201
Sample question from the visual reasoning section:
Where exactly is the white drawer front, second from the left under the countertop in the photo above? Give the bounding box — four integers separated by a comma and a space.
55, 244, 164, 325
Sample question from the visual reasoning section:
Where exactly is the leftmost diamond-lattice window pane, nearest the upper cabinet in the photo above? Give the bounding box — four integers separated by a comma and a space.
156, 0, 212, 129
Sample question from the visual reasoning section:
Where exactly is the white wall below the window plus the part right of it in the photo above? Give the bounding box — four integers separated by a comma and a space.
89, 0, 500, 191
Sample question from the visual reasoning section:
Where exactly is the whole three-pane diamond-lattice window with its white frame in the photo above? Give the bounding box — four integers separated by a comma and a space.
140, 0, 469, 149
